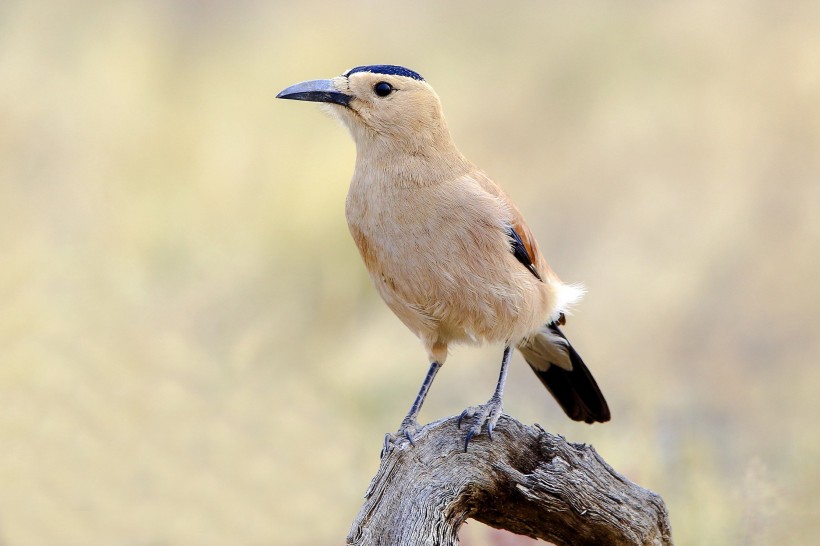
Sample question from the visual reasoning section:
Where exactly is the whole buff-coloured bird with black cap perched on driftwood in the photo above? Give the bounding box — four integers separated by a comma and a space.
276, 65, 610, 454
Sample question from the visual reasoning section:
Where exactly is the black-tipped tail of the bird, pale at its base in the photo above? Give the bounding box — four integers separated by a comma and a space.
518, 322, 610, 423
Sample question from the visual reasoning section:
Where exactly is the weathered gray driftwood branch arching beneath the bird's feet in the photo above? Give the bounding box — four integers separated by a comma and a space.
347, 415, 672, 546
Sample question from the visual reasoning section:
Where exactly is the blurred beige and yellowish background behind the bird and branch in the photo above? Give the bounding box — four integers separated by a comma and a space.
0, 0, 820, 546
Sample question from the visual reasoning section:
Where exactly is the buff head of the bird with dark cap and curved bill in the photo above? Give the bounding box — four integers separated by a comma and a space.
276, 65, 451, 154
